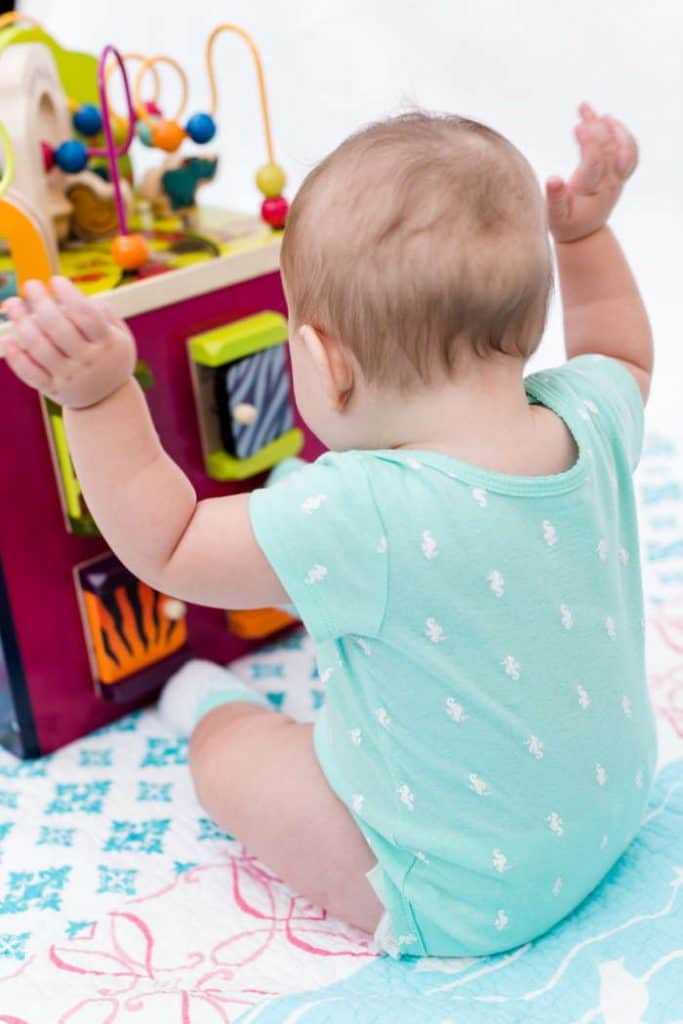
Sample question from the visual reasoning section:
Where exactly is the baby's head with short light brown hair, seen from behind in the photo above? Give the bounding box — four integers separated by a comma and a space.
282, 113, 552, 447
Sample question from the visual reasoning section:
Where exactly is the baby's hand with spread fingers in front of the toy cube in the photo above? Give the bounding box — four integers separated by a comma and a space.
5, 278, 136, 409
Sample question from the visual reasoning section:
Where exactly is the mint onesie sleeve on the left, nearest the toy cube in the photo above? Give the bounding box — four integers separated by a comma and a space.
250, 452, 387, 643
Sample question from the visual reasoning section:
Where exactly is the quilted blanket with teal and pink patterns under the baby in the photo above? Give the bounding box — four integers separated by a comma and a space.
0, 436, 683, 1024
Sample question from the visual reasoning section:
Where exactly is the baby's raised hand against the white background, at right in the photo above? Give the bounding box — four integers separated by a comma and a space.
546, 103, 638, 242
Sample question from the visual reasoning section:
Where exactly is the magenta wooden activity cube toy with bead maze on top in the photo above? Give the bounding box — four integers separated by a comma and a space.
0, 15, 318, 757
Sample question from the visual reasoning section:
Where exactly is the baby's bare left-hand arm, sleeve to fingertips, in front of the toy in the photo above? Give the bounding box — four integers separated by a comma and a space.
5, 278, 288, 608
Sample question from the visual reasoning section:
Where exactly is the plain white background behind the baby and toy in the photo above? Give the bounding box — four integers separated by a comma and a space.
24, 0, 683, 421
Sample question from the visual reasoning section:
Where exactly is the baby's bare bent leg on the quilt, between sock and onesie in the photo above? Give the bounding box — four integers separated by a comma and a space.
189, 702, 383, 932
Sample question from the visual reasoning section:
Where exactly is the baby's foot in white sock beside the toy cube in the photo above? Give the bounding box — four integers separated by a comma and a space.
158, 659, 270, 736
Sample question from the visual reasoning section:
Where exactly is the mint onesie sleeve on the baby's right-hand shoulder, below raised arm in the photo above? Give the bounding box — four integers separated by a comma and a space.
541, 355, 644, 473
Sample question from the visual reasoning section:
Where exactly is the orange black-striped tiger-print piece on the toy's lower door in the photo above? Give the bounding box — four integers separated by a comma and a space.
82, 582, 187, 684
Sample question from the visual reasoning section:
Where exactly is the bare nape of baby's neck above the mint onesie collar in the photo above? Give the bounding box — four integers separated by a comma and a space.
362, 356, 577, 476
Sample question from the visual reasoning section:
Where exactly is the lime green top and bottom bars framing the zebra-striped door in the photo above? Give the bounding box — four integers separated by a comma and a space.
187, 312, 303, 480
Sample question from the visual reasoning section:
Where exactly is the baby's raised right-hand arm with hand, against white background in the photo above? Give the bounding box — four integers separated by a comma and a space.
547, 103, 653, 400
